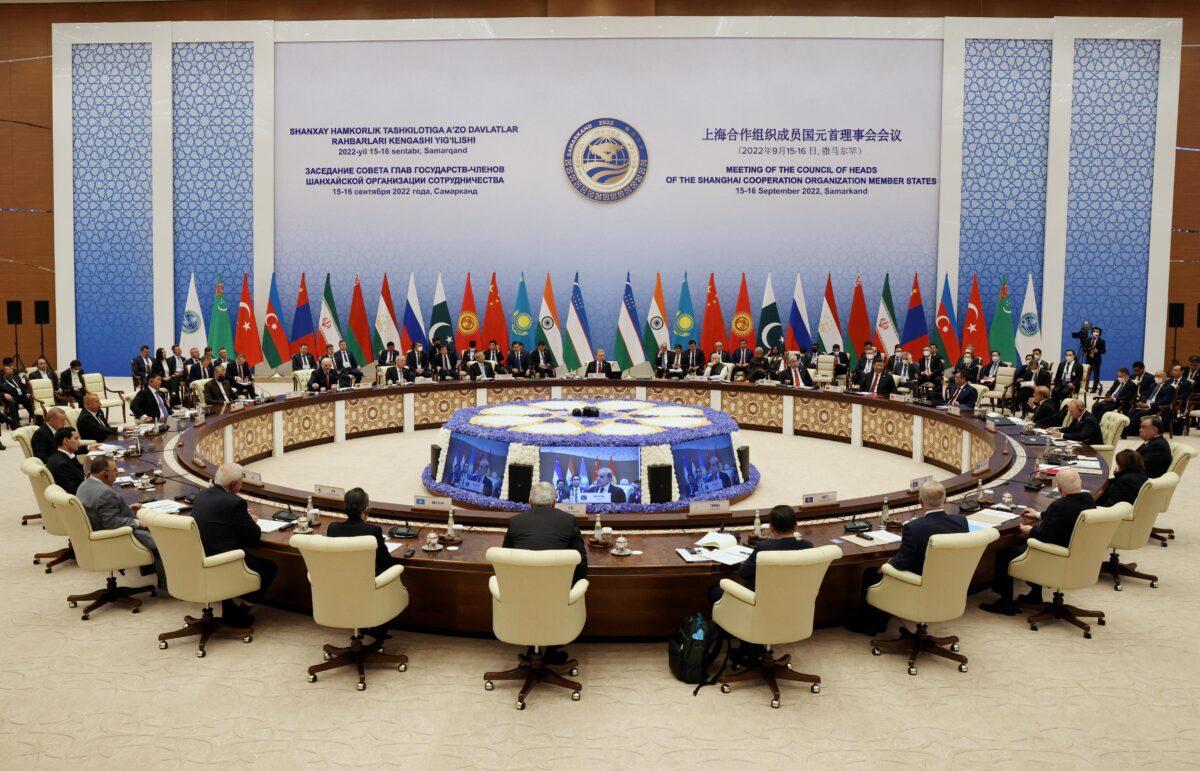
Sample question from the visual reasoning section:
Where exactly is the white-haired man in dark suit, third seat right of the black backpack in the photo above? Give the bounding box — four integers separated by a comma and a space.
979, 468, 1096, 616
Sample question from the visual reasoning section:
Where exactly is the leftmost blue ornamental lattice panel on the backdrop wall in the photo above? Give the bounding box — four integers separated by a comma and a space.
72, 43, 154, 376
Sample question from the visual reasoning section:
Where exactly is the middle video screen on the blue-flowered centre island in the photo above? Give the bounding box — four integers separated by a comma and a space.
541, 447, 642, 503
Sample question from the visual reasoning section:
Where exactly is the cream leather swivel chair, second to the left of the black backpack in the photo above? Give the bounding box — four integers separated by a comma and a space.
288, 536, 408, 691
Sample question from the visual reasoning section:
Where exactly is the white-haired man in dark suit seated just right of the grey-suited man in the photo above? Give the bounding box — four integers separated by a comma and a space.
192, 464, 278, 627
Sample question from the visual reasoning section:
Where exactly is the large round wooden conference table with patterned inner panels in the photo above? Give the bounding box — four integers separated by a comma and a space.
120, 379, 1108, 639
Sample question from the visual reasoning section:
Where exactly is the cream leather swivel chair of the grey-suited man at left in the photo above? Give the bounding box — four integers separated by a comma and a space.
46, 484, 157, 621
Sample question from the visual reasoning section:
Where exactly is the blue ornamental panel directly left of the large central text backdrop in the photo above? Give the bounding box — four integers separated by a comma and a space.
172, 42, 253, 339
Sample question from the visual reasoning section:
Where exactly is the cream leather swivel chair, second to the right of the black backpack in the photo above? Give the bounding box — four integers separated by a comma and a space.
866, 527, 1000, 675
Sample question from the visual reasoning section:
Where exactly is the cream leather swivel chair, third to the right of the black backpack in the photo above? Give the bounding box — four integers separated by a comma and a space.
1008, 503, 1133, 639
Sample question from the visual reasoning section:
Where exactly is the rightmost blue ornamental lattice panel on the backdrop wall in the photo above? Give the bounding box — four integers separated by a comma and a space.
1055, 40, 1159, 377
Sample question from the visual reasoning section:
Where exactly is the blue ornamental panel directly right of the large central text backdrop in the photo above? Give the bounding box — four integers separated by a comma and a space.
956, 40, 1054, 331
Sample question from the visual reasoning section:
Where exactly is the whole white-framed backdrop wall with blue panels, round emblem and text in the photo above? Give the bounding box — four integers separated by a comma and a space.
37, 17, 1181, 373
